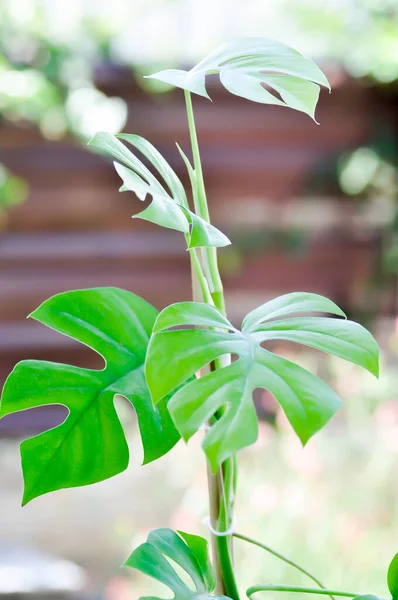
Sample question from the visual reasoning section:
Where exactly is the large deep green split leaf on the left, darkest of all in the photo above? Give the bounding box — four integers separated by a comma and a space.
0, 288, 179, 504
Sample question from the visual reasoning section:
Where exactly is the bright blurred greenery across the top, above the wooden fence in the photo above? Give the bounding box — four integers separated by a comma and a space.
0, 0, 398, 138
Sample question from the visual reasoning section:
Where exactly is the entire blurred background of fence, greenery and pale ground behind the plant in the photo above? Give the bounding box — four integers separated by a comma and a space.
0, 0, 398, 600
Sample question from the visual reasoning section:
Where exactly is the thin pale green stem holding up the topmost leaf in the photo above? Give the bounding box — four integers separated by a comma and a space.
184, 90, 225, 314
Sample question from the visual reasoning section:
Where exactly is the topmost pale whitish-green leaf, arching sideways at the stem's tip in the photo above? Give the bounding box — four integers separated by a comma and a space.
146, 38, 330, 118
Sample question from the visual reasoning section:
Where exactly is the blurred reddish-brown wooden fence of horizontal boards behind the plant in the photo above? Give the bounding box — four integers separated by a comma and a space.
0, 65, 392, 429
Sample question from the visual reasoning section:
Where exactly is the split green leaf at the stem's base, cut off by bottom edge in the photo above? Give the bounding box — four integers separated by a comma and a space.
125, 528, 226, 600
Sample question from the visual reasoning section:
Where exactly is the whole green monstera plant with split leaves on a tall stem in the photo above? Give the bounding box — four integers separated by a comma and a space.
0, 38, 398, 600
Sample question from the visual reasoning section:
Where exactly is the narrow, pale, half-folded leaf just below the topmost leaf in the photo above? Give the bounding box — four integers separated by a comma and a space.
89, 132, 230, 248
